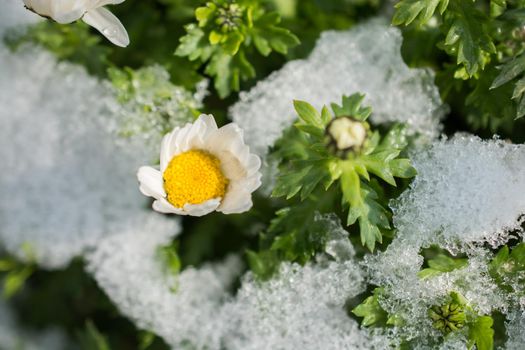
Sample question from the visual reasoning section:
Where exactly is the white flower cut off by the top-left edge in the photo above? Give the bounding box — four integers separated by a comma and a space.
24, 0, 129, 47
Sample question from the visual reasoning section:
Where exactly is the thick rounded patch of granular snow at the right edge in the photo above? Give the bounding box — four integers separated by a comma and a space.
393, 135, 525, 248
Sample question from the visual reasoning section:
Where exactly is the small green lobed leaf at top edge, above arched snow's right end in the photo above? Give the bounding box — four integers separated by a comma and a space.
392, 0, 448, 25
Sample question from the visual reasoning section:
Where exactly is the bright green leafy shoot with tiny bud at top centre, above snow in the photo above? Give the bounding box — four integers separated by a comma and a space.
175, 0, 299, 98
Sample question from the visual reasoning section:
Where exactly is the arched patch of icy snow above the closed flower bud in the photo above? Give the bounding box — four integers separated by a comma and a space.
230, 20, 444, 155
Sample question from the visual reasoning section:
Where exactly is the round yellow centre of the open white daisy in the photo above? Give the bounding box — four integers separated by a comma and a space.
162, 150, 228, 208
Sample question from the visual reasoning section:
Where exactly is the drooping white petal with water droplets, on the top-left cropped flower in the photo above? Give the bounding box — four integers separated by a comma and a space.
82, 7, 129, 47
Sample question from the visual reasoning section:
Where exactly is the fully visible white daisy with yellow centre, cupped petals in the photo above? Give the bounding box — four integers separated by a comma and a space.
137, 115, 261, 216
